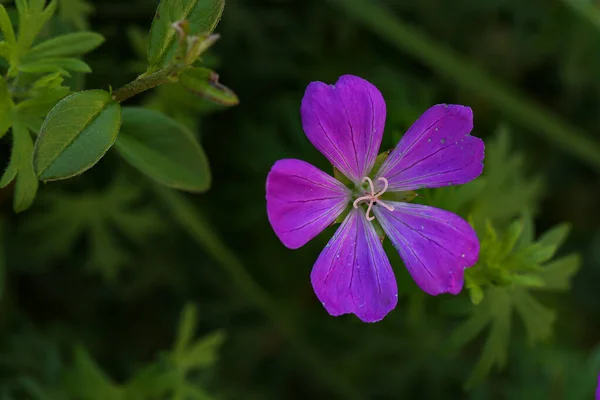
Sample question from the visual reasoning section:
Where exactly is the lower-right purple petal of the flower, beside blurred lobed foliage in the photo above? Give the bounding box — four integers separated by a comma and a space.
373, 201, 479, 296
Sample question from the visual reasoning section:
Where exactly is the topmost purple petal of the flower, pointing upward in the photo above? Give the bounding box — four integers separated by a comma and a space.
300, 75, 386, 183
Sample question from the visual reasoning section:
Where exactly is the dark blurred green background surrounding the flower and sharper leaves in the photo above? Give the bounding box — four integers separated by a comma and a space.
0, 0, 600, 400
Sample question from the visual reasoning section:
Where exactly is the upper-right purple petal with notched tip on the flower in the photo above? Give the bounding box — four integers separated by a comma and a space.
376, 104, 484, 191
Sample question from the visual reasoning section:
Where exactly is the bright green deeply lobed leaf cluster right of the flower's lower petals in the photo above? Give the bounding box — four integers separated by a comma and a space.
450, 217, 581, 387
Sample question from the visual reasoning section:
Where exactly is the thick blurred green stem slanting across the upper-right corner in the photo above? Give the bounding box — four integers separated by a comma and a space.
330, 0, 600, 172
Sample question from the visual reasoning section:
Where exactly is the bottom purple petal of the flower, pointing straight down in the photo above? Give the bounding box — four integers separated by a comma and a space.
310, 209, 398, 322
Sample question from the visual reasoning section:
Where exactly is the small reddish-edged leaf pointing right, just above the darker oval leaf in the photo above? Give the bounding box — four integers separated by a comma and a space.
179, 68, 239, 106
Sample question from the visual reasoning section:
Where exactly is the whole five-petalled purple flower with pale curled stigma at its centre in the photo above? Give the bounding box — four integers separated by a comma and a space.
267, 75, 484, 322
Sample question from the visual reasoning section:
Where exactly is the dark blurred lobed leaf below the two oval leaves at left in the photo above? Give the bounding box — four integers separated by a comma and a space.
23, 177, 162, 280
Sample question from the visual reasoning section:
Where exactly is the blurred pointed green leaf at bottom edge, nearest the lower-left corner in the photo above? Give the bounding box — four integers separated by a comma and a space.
66, 347, 123, 400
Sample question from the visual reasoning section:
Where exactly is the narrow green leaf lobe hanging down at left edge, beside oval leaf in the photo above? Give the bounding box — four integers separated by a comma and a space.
0, 118, 38, 212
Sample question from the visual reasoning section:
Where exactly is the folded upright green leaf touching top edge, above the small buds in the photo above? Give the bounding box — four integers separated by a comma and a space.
148, 0, 225, 71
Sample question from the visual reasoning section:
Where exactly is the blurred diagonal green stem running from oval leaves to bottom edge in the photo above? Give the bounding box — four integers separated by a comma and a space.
154, 185, 362, 400
